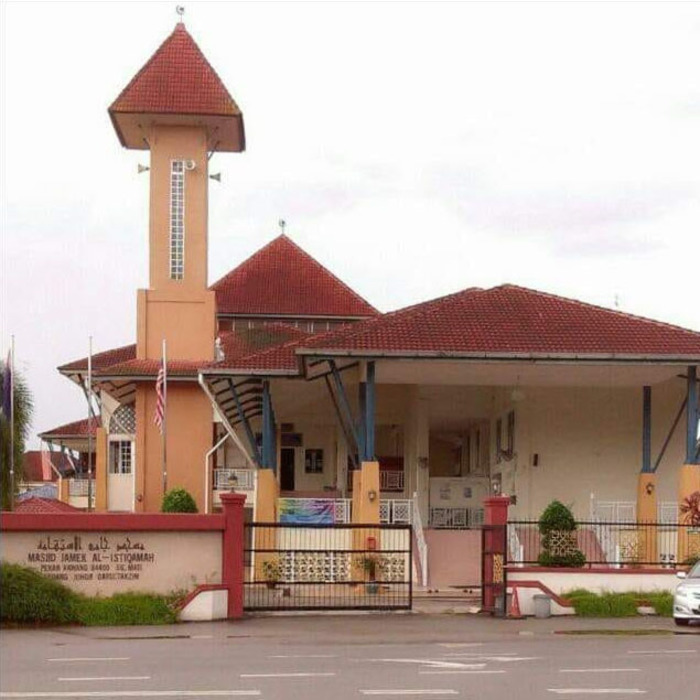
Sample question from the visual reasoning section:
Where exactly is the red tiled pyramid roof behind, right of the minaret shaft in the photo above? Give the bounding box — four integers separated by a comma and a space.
211, 235, 378, 318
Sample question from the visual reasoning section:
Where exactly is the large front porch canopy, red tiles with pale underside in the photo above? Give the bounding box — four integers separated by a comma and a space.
295, 285, 700, 471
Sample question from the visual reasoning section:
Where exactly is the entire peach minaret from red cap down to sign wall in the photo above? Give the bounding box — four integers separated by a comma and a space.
105, 23, 245, 511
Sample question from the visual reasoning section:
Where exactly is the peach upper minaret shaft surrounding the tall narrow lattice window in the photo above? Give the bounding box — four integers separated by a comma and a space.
149, 125, 209, 292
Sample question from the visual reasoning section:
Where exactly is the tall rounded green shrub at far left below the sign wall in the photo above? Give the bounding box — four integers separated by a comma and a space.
0, 562, 80, 624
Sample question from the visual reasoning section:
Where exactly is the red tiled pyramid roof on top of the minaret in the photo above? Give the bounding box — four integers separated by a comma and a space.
109, 23, 241, 117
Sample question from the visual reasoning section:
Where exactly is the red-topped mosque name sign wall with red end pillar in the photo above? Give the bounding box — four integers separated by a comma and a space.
0, 493, 245, 619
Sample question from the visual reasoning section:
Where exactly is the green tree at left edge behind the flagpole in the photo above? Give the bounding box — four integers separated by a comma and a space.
0, 360, 34, 510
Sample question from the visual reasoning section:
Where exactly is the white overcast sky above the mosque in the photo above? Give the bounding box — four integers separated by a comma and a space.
0, 1, 700, 446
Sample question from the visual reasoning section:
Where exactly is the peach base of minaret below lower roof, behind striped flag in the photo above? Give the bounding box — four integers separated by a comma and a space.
136, 381, 212, 512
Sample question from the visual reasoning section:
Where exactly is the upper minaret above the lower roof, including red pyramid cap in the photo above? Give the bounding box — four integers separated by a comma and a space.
109, 22, 245, 360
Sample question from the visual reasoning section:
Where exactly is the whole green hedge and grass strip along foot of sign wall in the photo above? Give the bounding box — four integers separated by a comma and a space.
0, 562, 181, 627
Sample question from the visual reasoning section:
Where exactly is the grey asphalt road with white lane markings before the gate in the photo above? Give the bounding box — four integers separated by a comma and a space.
0, 615, 700, 700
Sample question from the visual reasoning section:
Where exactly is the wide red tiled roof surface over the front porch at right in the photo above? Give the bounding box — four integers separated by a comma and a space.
298, 285, 700, 359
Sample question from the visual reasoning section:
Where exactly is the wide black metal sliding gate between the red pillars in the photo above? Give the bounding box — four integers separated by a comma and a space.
244, 523, 413, 610
